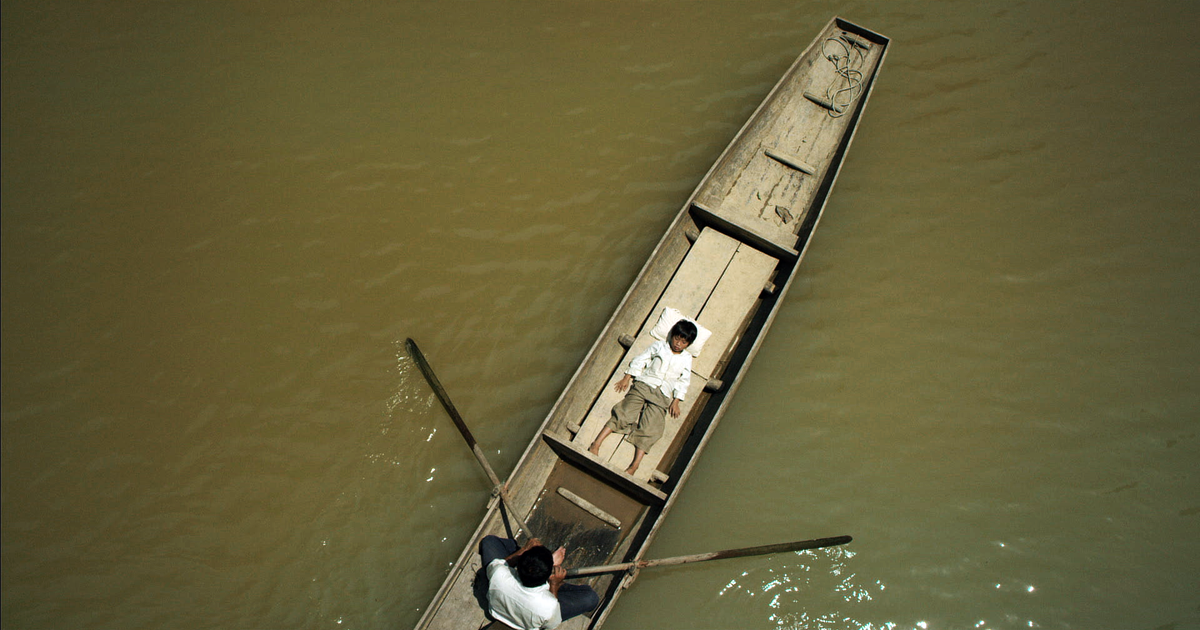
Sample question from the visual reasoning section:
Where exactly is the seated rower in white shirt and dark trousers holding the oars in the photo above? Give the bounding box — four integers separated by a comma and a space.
476, 536, 600, 630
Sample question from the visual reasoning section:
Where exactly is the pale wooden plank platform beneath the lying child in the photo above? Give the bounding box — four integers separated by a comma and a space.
561, 228, 779, 484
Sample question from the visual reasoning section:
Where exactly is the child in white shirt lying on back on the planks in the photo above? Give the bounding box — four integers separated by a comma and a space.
588, 319, 698, 475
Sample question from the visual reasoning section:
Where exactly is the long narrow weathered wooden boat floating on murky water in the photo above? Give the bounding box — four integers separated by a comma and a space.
416, 18, 889, 630
